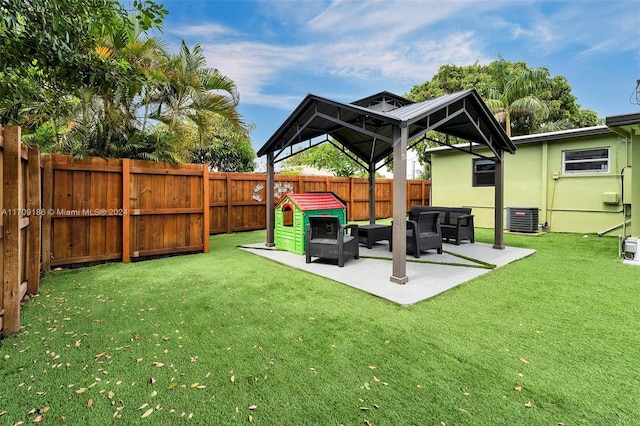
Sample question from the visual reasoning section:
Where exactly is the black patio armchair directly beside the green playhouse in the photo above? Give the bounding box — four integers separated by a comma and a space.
305, 215, 360, 267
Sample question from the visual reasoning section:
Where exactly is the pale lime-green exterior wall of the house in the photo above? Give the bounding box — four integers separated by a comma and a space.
431, 132, 631, 235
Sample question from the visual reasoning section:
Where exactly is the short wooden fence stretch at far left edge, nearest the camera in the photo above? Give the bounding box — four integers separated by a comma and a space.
0, 126, 43, 335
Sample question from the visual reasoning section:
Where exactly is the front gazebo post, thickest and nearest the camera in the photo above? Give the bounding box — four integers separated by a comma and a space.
390, 122, 409, 284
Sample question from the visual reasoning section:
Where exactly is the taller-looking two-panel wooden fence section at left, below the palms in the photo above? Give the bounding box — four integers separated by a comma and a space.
42, 154, 209, 270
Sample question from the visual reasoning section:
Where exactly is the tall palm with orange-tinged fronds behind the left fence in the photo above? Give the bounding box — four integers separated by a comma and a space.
58, 14, 165, 158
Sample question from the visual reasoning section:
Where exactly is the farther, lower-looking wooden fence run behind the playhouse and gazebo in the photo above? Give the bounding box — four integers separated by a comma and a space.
209, 173, 431, 234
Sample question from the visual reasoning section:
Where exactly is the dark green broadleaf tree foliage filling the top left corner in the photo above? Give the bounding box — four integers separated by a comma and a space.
0, 0, 167, 124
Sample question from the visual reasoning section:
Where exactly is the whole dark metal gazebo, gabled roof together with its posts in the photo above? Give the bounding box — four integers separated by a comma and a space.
257, 89, 516, 284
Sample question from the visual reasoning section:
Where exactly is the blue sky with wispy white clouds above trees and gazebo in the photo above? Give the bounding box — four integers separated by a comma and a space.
152, 0, 640, 160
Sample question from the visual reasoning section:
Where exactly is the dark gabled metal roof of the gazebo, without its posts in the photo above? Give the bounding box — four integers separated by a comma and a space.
257, 89, 516, 164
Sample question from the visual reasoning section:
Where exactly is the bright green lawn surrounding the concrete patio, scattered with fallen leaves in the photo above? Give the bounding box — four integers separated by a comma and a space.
0, 230, 640, 425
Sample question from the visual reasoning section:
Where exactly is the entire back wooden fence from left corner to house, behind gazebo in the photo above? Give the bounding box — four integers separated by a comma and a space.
42, 158, 430, 270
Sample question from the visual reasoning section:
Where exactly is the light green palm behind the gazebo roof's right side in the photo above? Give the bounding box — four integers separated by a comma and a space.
484, 57, 552, 137
